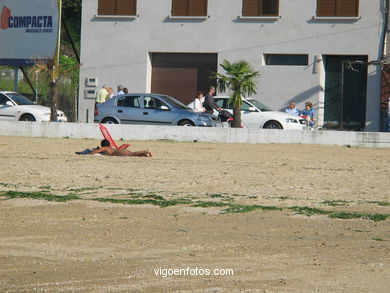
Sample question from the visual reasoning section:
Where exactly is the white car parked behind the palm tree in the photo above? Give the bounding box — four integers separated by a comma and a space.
214, 96, 306, 130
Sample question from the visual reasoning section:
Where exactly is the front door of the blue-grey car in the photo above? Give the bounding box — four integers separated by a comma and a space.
139, 95, 174, 125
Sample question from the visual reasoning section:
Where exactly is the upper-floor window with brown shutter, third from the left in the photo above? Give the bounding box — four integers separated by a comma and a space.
242, 0, 279, 16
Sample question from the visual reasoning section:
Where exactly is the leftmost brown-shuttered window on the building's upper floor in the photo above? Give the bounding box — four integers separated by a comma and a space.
98, 0, 137, 15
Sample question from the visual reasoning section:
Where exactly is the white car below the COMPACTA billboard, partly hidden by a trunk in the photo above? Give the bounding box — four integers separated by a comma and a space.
0, 91, 68, 122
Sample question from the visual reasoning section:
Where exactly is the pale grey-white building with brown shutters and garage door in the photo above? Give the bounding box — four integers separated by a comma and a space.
79, 0, 386, 131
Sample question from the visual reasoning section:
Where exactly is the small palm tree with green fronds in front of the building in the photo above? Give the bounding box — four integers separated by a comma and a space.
213, 60, 260, 127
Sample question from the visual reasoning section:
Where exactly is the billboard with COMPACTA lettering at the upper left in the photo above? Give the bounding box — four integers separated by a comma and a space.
0, 0, 61, 66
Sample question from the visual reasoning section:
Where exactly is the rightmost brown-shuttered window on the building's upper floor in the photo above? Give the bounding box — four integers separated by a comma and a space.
317, 0, 359, 17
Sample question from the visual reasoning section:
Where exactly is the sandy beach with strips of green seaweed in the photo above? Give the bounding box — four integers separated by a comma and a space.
0, 136, 390, 292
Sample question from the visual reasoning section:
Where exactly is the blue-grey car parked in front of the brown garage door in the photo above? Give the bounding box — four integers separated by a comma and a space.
94, 93, 218, 127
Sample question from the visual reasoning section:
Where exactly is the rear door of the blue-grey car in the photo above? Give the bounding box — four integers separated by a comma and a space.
114, 95, 143, 124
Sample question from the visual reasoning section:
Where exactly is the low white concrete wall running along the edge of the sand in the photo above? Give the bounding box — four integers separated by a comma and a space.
0, 121, 390, 148
